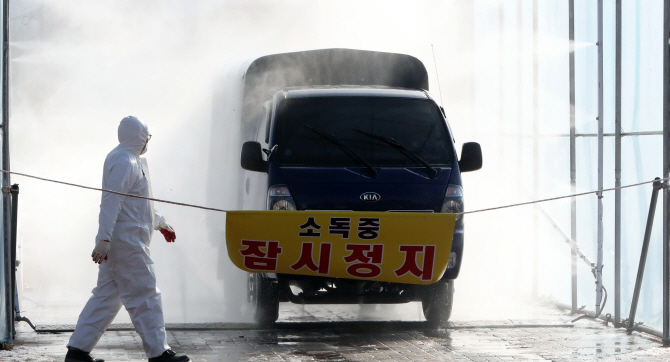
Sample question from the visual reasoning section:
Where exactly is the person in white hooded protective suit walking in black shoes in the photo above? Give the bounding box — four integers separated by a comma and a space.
65, 116, 189, 362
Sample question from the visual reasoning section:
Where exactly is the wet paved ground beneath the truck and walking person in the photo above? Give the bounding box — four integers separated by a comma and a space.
0, 304, 670, 361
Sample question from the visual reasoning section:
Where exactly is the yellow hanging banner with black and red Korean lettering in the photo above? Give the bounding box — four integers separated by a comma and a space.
226, 211, 456, 284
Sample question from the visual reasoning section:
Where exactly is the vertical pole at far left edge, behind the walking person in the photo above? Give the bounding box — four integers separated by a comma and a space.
2, 0, 14, 344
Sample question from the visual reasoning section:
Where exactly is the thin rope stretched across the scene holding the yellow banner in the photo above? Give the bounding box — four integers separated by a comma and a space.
0, 170, 670, 215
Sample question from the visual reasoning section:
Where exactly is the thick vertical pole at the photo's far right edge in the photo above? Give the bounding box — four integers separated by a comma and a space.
663, 1, 670, 346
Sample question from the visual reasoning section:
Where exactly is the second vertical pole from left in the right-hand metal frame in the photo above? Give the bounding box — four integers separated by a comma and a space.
596, 0, 603, 314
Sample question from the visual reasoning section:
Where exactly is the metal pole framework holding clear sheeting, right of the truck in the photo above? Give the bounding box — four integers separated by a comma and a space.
558, 0, 670, 340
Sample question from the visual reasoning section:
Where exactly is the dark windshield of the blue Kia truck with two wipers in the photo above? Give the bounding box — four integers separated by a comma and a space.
275, 97, 453, 167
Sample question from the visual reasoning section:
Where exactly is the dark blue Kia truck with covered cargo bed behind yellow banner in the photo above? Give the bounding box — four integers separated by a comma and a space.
241, 49, 482, 325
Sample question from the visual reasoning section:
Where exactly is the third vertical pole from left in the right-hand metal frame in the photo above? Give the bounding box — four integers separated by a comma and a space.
614, 0, 621, 327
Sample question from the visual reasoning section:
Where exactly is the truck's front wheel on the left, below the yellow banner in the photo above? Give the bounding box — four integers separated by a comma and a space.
248, 273, 279, 326
